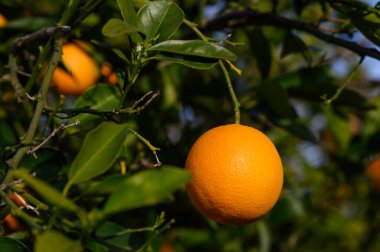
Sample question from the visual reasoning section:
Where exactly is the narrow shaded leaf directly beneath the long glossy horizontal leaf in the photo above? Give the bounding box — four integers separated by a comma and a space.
148, 54, 218, 70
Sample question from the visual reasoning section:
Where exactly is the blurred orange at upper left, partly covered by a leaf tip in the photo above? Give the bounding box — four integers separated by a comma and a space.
52, 43, 99, 95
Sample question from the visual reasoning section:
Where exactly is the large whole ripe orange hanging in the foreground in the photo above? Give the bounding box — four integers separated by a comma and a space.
185, 124, 283, 224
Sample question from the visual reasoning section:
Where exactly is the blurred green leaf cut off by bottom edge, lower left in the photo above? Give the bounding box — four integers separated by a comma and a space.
34, 230, 83, 252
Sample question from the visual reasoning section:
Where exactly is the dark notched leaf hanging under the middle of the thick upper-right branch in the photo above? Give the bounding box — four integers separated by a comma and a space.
281, 31, 312, 62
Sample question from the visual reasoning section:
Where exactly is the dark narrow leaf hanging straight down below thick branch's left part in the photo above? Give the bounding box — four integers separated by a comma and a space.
248, 28, 272, 79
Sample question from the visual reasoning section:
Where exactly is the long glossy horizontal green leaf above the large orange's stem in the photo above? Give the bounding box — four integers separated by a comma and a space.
148, 40, 236, 60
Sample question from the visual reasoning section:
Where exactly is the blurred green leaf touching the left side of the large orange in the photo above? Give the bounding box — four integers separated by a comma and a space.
103, 166, 191, 215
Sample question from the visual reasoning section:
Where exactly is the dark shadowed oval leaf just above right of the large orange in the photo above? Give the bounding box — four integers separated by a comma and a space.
260, 81, 297, 119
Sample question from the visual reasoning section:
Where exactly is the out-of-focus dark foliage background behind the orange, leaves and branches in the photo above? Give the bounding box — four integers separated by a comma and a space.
0, 0, 380, 252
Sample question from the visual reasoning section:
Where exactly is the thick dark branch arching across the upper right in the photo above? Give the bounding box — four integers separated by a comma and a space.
202, 10, 380, 60
